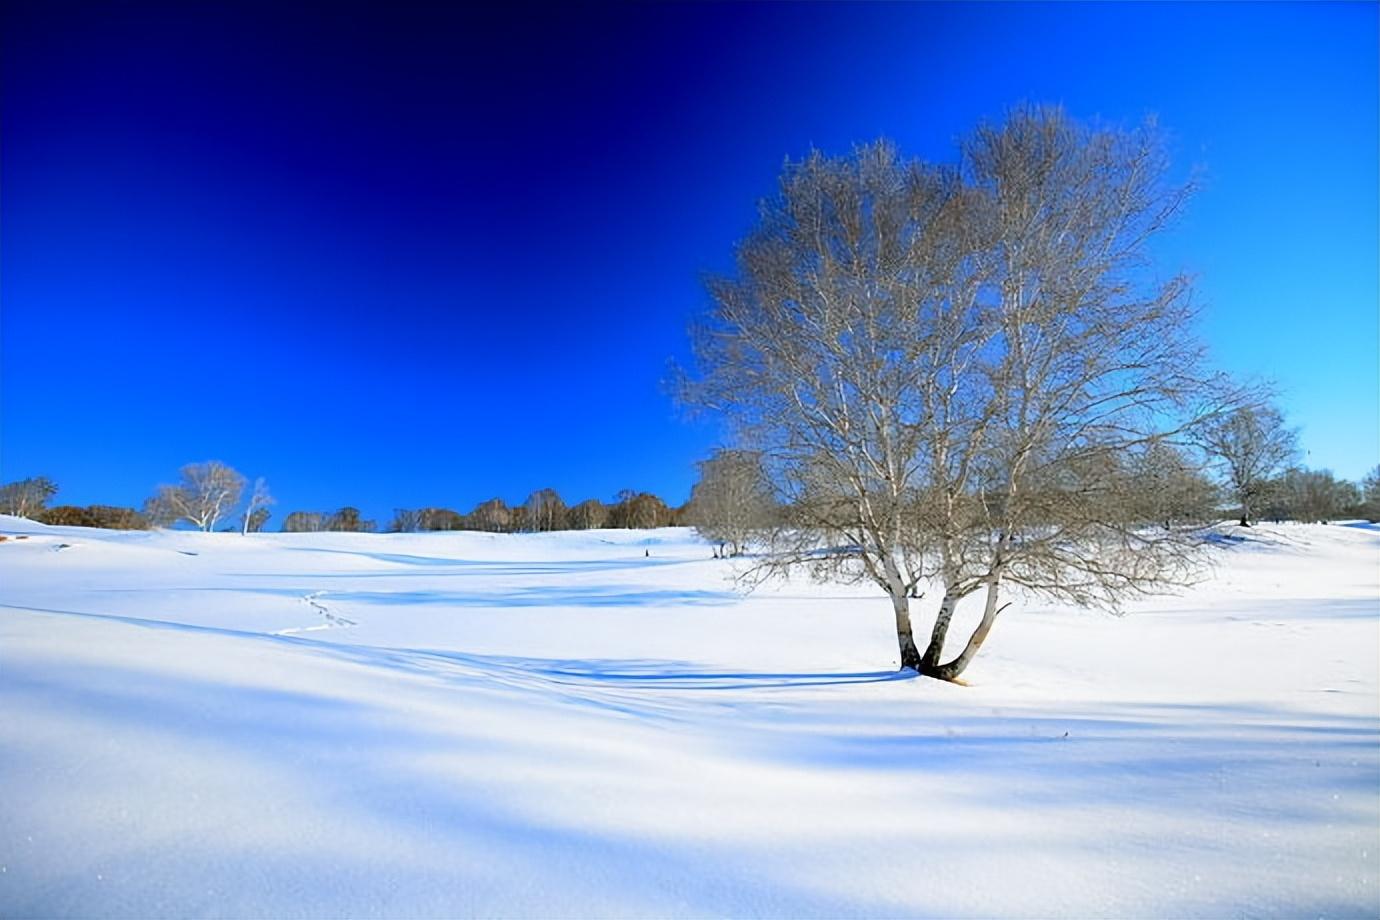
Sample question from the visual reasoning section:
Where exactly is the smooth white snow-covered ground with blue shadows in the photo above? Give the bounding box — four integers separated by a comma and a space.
0, 517, 1380, 917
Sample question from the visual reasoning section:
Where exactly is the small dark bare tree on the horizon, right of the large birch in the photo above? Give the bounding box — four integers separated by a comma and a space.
1198, 406, 1299, 527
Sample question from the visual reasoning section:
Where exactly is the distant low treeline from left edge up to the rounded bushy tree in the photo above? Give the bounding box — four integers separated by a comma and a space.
0, 461, 690, 534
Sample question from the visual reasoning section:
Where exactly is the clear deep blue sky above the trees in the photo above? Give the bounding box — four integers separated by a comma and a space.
0, 0, 1380, 527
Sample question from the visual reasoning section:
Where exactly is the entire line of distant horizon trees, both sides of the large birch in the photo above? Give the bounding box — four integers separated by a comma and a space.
0, 430, 1380, 540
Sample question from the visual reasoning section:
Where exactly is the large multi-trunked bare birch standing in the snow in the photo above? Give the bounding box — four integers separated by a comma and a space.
683, 109, 1227, 680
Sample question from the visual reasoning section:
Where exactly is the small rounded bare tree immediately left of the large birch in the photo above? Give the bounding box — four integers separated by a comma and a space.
689, 448, 776, 556
